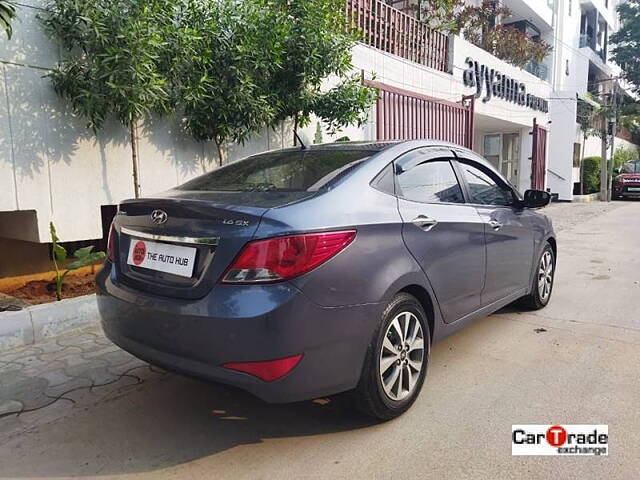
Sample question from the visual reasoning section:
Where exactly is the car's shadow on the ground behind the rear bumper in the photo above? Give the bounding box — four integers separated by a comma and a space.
0, 374, 377, 478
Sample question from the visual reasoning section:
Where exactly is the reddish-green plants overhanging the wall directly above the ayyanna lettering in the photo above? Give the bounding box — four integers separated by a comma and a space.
457, 1, 552, 68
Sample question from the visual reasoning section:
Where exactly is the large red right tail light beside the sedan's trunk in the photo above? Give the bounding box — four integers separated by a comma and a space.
222, 230, 356, 283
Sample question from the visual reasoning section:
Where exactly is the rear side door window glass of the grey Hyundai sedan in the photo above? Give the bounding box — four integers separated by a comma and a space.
397, 158, 464, 203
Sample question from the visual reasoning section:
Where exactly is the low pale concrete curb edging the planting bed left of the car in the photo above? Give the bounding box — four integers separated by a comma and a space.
0, 294, 99, 352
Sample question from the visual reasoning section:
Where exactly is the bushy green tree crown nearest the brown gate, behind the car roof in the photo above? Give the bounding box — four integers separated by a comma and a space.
171, 0, 376, 156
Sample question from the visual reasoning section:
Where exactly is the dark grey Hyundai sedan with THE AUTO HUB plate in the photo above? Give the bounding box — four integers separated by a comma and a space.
97, 141, 556, 419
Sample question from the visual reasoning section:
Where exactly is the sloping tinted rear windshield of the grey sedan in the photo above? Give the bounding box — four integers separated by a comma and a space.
178, 149, 375, 192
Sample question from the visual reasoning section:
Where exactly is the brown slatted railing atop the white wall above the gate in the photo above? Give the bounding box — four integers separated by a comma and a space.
347, 0, 449, 72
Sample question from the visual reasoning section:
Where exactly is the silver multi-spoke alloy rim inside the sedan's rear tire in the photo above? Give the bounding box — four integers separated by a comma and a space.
379, 312, 424, 401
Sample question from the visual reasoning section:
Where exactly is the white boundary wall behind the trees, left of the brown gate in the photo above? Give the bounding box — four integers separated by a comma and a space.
0, 0, 376, 242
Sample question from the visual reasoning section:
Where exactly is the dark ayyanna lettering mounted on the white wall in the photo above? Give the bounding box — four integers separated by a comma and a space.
463, 57, 549, 113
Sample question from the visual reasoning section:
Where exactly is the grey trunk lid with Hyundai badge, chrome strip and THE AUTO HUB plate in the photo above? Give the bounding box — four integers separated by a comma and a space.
114, 191, 299, 299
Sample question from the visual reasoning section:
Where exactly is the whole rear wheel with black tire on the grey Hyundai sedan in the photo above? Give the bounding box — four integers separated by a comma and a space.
354, 293, 431, 420
